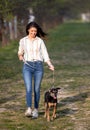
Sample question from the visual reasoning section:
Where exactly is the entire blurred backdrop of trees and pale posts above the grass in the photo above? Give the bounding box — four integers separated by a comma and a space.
0, 0, 90, 46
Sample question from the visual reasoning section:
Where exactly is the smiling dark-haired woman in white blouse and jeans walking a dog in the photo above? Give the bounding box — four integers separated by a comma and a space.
18, 22, 54, 118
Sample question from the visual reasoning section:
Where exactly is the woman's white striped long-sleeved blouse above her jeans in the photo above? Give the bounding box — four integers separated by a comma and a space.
18, 36, 50, 62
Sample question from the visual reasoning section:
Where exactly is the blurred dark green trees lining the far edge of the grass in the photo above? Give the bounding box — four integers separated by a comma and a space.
0, 0, 90, 43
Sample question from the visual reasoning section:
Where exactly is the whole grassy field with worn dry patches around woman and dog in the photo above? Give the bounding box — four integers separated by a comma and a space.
0, 23, 90, 130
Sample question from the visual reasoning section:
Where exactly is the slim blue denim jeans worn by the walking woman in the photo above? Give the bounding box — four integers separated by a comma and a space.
23, 61, 44, 109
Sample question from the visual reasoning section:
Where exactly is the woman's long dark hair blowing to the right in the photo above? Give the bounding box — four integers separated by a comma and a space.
26, 22, 47, 37
